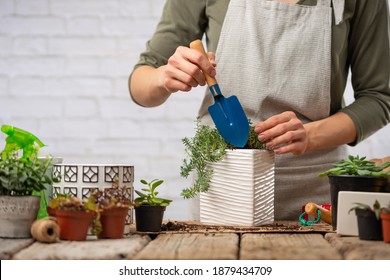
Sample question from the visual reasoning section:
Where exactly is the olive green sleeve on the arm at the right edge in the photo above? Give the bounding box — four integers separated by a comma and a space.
341, 0, 390, 145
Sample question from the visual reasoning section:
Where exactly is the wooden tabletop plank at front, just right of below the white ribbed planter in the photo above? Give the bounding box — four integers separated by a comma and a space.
240, 233, 341, 260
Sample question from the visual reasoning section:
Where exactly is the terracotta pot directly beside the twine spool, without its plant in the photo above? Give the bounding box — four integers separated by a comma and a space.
56, 209, 92, 241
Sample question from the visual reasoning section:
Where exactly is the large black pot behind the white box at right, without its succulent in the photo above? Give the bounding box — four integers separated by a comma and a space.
328, 175, 390, 230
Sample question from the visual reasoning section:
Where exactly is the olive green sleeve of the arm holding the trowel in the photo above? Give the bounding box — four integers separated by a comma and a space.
135, 0, 207, 68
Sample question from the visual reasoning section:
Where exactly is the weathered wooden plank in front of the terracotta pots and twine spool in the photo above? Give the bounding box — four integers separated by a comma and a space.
13, 235, 150, 260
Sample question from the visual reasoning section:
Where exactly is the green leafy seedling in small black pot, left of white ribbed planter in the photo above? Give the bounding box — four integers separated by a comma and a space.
134, 179, 172, 232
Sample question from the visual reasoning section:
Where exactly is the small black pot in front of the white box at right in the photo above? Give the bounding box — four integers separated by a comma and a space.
355, 209, 383, 240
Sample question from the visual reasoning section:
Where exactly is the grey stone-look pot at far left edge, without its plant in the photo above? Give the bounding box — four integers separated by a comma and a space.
0, 196, 40, 238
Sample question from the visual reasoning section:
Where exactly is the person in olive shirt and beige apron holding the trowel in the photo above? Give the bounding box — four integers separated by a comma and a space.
129, 0, 390, 219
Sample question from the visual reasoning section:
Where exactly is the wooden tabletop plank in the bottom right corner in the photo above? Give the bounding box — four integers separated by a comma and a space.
325, 233, 390, 260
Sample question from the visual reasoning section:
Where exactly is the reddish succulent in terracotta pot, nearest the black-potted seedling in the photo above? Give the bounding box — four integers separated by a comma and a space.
90, 180, 132, 238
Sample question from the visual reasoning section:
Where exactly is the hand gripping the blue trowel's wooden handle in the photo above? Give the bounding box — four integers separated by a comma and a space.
163, 46, 216, 93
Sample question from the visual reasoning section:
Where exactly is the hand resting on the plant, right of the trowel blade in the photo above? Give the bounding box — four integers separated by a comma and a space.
254, 111, 308, 155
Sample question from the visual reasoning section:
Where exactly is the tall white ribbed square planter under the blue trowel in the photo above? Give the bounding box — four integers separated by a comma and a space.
200, 149, 275, 226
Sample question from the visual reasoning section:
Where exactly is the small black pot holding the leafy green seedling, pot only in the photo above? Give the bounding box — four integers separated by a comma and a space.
134, 205, 166, 232
